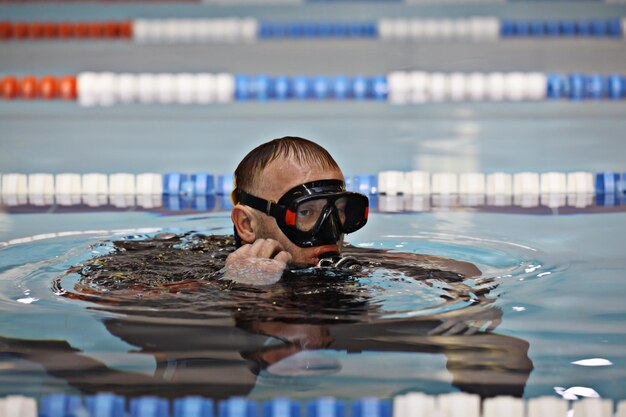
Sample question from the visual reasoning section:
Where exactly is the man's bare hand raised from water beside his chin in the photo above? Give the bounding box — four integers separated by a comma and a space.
224, 239, 291, 285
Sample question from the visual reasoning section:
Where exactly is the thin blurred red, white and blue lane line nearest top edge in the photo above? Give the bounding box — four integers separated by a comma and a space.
0, 16, 626, 44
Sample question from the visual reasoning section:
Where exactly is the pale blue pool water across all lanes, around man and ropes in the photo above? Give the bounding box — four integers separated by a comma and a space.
0, 2, 626, 400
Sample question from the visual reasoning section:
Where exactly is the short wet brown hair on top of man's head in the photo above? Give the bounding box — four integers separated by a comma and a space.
232, 136, 339, 204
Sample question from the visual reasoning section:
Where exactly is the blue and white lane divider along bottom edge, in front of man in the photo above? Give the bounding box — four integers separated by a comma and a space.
0, 387, 626, 417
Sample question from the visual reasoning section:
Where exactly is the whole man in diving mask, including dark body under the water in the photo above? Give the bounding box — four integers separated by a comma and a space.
8, 138, 532, 399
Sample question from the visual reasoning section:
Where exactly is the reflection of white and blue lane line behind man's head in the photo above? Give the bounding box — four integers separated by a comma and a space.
0, 194, 626, 216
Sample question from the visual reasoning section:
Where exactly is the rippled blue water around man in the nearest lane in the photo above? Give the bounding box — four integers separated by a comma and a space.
0, 211, 626, 399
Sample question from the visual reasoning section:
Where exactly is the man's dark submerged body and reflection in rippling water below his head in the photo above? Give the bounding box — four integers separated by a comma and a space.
0, 233, 532, 398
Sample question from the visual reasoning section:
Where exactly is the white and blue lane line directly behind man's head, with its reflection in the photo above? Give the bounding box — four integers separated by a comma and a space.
0, 171, 626, 215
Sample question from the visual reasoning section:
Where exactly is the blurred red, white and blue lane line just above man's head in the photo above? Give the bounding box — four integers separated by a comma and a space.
0, 71, 626, 102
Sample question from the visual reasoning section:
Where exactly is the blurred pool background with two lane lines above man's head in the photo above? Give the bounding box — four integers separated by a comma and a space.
0, 0, 626, 178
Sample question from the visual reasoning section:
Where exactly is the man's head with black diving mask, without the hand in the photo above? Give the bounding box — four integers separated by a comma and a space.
231, 137, 367, 266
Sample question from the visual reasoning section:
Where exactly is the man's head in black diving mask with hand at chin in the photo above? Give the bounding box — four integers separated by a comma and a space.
225, 137, 480, 285
